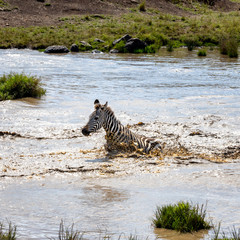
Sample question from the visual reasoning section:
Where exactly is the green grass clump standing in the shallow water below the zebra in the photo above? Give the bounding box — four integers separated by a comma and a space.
153, 202, 211, 232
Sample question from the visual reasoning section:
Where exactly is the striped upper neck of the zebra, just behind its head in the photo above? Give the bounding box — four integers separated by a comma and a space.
103, 107, 124, 134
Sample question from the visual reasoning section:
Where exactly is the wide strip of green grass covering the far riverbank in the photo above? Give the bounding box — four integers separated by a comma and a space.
0, 10, 240, 56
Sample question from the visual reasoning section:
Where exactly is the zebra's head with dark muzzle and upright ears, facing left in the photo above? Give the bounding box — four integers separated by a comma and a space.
82, 99, 108, 136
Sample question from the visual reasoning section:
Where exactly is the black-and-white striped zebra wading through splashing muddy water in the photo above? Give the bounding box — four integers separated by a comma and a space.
82, 99, 162, 154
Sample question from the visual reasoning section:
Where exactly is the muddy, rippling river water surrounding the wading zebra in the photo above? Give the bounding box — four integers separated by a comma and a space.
0, 49, 240, 239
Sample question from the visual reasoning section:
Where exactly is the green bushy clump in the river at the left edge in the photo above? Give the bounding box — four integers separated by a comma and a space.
0, 73, 46, 101
